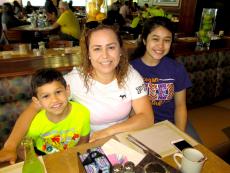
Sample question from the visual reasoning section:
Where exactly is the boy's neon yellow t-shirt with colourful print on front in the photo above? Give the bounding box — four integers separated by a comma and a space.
27, 101, 90, 154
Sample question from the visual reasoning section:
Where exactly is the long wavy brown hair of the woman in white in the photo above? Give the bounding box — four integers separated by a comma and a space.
80, 25, 129, 89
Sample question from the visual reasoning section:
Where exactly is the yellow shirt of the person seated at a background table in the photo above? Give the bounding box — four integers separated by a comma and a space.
57, 10, 80, 39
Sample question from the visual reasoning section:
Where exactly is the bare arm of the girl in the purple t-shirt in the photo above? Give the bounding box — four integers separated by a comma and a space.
174, 89, 187, 131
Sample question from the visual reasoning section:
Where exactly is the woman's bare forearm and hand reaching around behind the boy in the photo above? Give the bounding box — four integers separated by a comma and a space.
0, 102, 40, 164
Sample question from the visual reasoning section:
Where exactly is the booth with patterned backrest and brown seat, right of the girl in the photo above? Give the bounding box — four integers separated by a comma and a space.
176, 49, 230, 161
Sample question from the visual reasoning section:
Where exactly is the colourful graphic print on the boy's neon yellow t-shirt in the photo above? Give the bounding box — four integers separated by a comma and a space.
40, 128, 80, 153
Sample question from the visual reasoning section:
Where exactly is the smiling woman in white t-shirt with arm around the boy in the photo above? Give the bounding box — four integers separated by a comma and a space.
0, 26, 154, 163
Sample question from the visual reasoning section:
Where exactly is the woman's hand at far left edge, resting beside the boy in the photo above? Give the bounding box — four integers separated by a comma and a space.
0, 148, 17, 164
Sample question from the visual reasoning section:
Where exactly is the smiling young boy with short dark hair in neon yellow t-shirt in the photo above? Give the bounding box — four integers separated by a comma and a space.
26, 69, 90, 154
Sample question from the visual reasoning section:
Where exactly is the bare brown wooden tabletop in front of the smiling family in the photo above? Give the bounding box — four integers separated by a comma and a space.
43, 130, 230, 173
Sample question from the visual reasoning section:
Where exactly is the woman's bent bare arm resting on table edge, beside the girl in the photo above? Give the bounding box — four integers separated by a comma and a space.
90, 96, 154, 142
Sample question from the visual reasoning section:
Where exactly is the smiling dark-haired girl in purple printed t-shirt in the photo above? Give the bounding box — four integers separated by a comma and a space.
131, 17, 197, 139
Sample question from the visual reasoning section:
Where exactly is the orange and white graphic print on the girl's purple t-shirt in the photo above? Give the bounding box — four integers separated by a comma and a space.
144, 78, 174, 106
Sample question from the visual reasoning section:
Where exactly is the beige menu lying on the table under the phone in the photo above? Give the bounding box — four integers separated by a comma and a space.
116, 120, 198, 157
